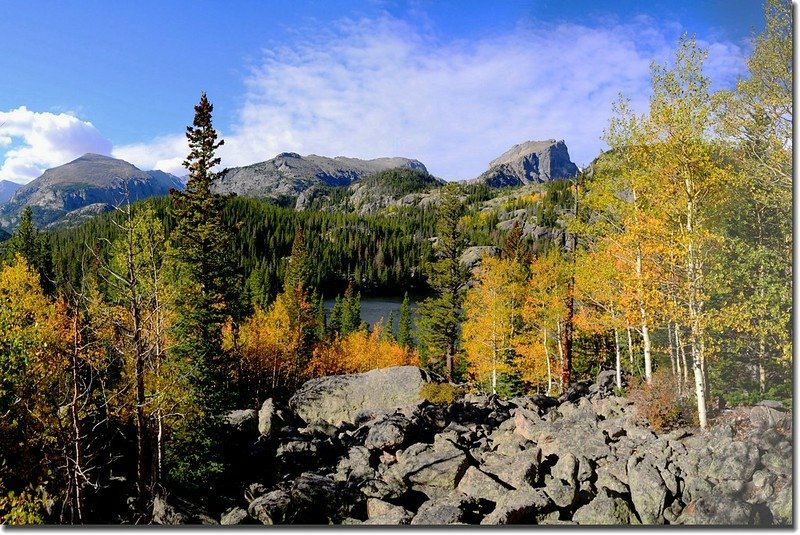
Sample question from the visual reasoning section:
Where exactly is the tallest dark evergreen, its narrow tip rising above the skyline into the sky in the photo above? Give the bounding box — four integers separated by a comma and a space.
167, 93, 239, 498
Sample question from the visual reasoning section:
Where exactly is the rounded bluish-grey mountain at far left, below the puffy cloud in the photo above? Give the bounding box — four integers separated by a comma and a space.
0, 154, 182, 228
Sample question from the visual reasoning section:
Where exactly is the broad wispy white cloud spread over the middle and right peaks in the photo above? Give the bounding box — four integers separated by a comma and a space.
216, 17, 743, 179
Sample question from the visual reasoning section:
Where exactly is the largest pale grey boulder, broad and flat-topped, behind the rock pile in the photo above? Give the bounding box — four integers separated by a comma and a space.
289, 366, 427, 425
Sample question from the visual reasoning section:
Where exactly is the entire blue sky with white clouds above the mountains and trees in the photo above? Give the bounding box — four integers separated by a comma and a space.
0, 0, 763, 182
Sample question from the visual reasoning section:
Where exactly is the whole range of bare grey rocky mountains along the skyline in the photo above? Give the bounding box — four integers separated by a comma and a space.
0, 139, 578, 230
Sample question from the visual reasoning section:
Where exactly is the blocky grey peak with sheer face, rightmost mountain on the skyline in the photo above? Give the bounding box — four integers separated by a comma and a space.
475, 139, 578, 188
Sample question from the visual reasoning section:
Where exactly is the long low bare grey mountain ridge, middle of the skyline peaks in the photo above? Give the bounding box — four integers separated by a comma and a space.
215, 152, 427, 197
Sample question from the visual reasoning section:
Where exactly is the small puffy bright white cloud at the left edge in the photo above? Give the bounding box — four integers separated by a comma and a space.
0, 106, 111, 183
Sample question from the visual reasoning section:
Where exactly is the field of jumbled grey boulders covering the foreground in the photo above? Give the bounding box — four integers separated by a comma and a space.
209, 367, 792, 526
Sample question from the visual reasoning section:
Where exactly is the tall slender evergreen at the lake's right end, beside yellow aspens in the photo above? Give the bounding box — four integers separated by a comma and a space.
419, 183, 469, 381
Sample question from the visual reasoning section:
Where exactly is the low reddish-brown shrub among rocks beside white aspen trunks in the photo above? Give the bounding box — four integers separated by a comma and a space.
628, 368, 693, 430
